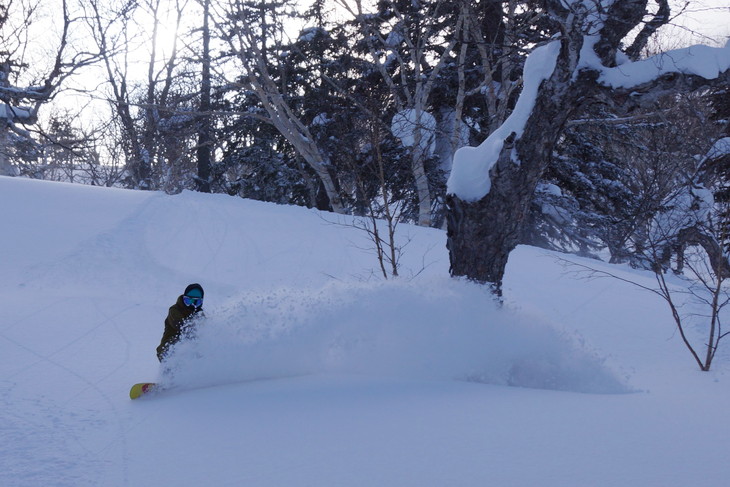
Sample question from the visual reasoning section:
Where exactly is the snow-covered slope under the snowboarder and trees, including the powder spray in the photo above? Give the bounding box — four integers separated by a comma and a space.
0, 178, 730, 487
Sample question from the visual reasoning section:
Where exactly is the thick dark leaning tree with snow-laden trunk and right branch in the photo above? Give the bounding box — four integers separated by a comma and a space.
440, 0, 730, 295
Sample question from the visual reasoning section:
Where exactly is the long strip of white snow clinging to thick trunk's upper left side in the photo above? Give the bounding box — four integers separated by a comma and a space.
446, 41, 560, 201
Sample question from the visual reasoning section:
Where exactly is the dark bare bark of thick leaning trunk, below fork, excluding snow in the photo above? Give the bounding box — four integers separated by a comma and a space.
440, 34, 580, 296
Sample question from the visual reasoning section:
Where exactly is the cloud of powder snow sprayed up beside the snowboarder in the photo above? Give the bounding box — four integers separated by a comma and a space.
162, 279, 627, 393
